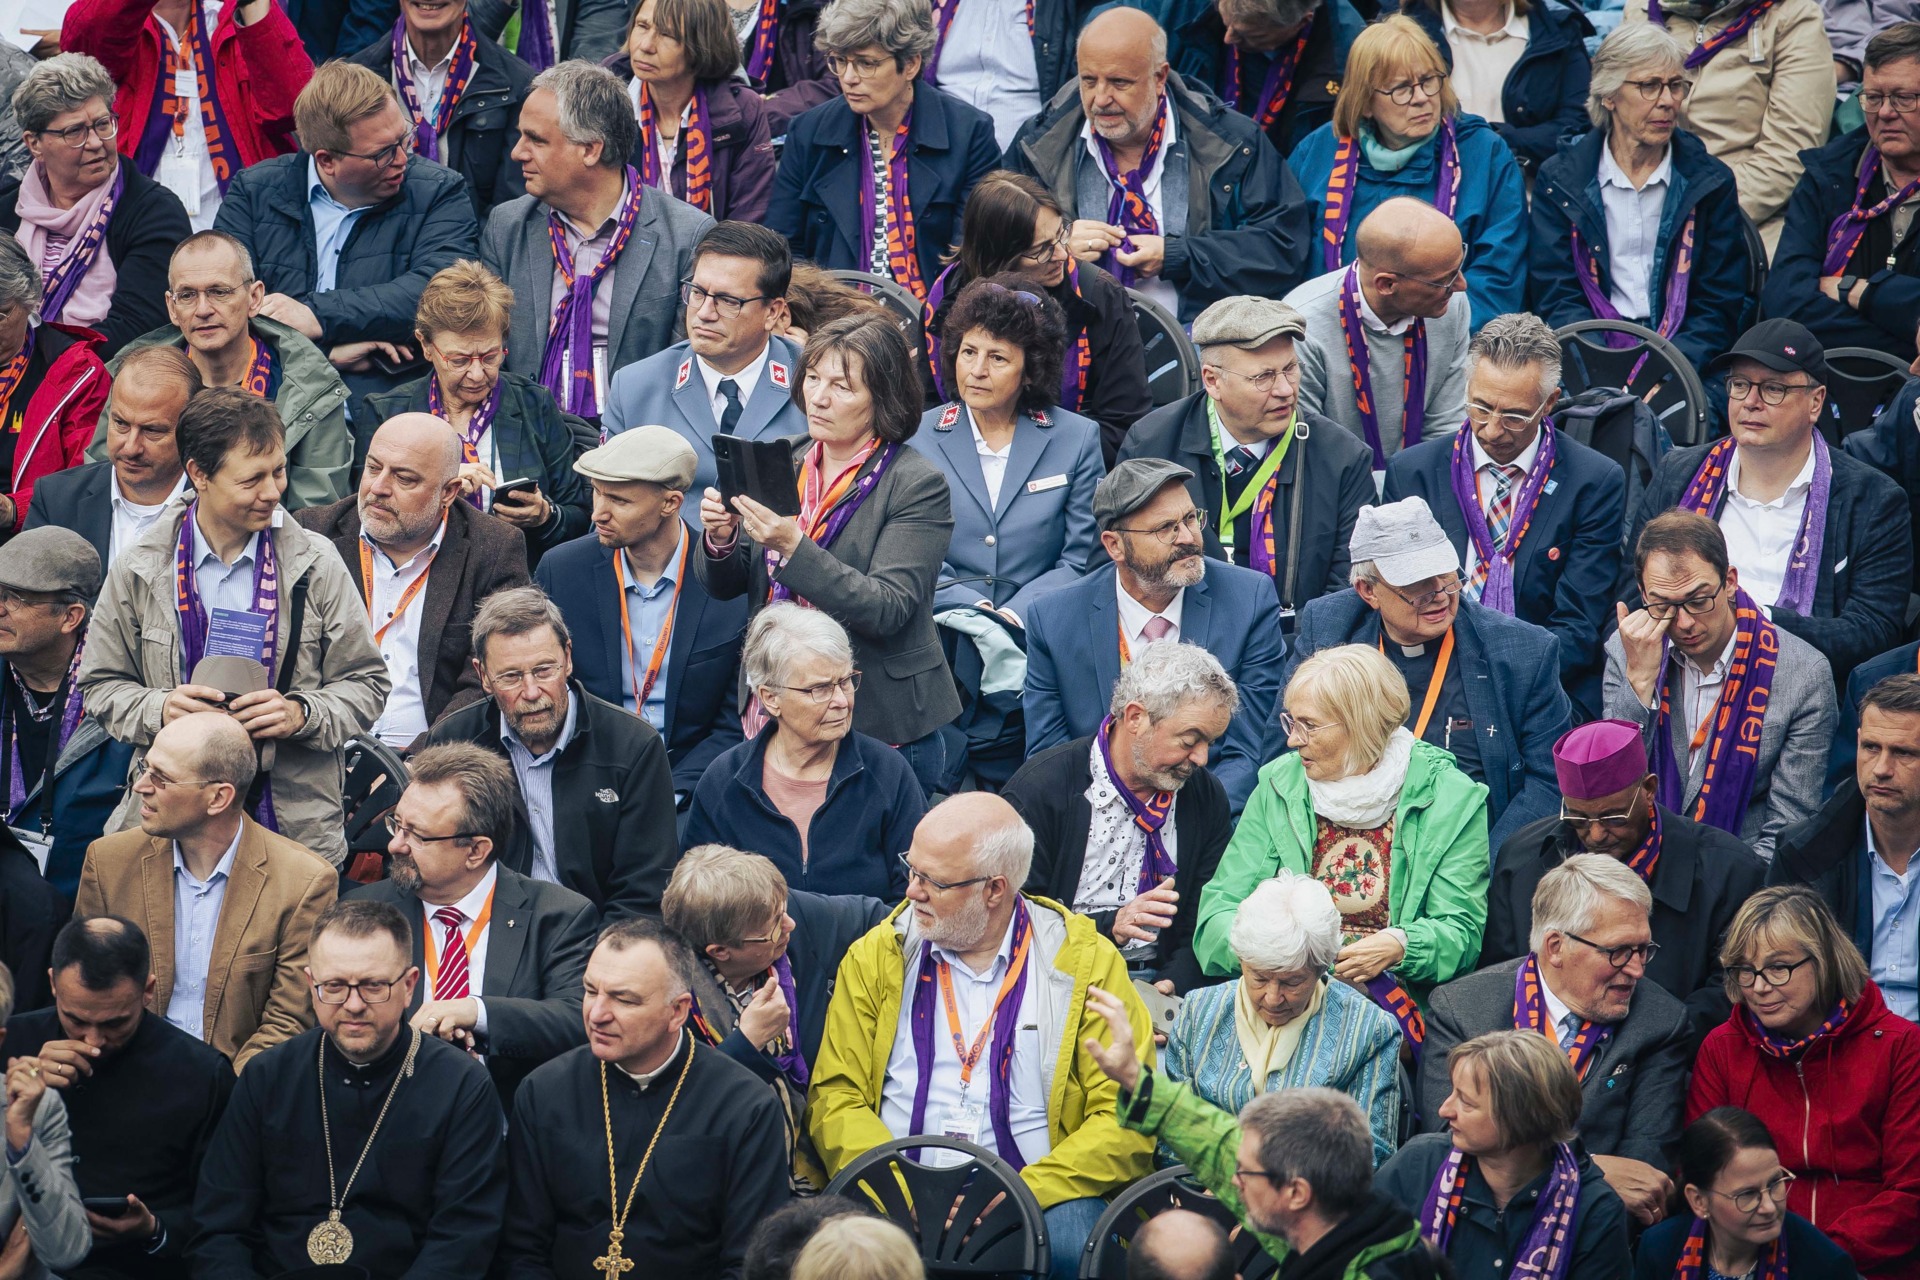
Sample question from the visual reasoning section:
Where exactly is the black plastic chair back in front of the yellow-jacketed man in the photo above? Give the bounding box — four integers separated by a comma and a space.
828, 1134, 1052, 1280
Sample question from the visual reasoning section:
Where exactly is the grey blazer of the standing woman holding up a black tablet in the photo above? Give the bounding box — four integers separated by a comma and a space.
693, 436, 960, 745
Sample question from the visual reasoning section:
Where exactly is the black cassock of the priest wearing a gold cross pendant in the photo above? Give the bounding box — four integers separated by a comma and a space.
501, 1032, 789, 1280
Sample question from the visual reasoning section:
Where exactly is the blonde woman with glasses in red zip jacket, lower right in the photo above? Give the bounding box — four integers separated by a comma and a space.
1686, 885, 1920, 1280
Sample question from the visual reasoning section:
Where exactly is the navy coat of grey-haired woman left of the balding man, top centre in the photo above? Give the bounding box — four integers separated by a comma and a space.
766, 83, 1000, 286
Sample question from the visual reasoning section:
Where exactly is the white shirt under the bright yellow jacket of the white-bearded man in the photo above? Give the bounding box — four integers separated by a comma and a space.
879, 909, 1060, 1165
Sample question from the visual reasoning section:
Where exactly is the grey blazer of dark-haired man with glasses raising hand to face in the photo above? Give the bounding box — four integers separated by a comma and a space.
1603, 628, 1839, 862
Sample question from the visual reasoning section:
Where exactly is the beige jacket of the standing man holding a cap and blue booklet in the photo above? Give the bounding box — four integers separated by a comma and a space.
79, 507, 392, 865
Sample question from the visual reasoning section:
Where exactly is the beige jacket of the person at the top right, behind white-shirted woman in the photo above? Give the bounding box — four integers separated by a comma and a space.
1626, 0, 1834, 257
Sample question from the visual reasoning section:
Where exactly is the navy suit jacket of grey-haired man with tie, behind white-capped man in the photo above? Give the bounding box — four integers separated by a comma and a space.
1380, 428, 1626, 720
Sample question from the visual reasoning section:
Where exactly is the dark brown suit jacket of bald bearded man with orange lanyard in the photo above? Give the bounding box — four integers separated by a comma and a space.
294, 497, 530, 725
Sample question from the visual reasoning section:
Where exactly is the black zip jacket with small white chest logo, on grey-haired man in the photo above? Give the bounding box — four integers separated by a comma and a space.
426, 681, 680, 923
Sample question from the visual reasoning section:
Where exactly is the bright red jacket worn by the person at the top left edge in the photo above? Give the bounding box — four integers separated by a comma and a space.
60, 0, 313, 173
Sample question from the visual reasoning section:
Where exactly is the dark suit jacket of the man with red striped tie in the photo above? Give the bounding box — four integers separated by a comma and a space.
348, 867, 599, 1107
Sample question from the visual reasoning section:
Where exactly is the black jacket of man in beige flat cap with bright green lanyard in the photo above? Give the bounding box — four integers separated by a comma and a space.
1116, 391, 1375, 618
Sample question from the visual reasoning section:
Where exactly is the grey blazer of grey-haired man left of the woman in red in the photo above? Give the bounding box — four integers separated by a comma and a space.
1419, 956, 1693, 1169
